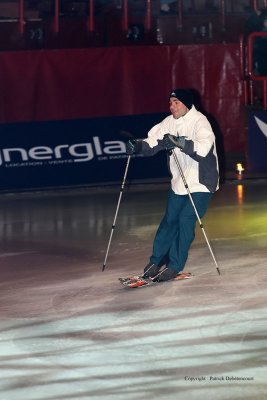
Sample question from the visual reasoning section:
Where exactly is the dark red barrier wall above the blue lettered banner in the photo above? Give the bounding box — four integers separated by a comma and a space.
0, 44, 245, 152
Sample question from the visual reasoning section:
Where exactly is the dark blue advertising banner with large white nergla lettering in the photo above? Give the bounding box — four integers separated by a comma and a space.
0, 114, 168, 191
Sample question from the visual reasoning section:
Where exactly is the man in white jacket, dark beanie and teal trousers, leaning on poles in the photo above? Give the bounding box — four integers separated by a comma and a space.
126, 89, 219, 282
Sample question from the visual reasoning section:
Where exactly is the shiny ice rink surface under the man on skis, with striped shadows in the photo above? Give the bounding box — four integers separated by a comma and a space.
0, 179, 267, 400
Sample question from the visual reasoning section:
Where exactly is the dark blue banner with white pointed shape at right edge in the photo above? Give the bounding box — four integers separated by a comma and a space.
248, 110, 267, 172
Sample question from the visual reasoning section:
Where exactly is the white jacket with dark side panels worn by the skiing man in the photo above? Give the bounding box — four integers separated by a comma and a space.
140, 106, 219, 195
